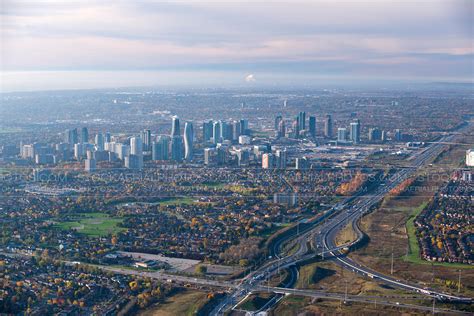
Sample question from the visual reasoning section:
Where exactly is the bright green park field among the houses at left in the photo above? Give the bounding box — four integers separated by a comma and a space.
56, 213, 125, 237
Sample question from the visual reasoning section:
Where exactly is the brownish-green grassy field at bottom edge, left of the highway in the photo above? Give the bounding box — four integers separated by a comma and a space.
138, 290, 207, 316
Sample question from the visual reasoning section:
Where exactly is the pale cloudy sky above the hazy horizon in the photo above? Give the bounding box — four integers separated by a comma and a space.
0, 0, 474, 92
